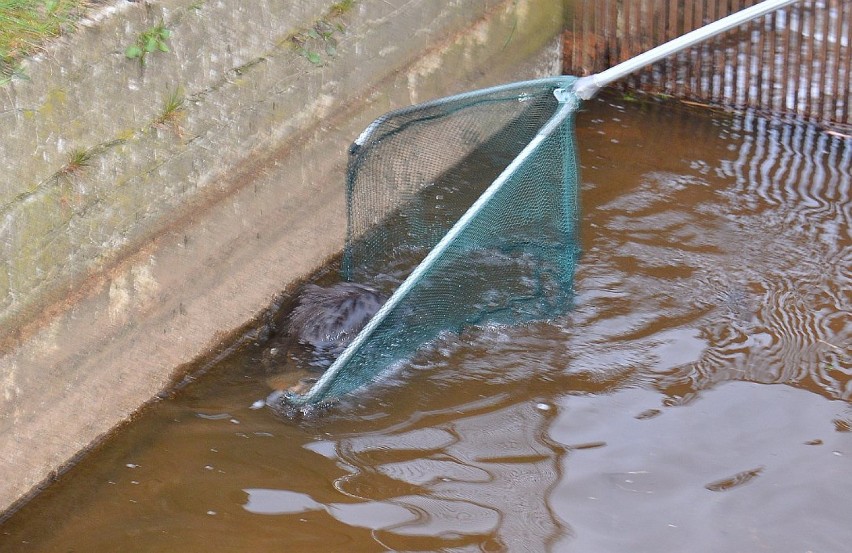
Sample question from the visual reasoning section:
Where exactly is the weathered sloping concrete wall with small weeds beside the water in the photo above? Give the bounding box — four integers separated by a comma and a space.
0, 0, 562, 511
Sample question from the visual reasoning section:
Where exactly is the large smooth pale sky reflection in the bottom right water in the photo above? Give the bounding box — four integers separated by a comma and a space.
550, 383, 852, 553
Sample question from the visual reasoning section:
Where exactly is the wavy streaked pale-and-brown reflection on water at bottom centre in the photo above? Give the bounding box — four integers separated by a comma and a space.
326, 394, 564, 551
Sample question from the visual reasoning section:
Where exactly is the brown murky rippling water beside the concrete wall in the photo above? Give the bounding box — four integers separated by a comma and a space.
0, 92, 852, 553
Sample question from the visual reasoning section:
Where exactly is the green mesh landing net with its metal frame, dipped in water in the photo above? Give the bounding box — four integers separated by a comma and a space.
283, 77, 579, 406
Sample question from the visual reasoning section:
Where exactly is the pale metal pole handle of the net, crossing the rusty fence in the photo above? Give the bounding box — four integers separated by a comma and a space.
574, 0, 798, 100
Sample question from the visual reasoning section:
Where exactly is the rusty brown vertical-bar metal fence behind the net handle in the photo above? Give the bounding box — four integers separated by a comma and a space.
564, 0, 852, 125
